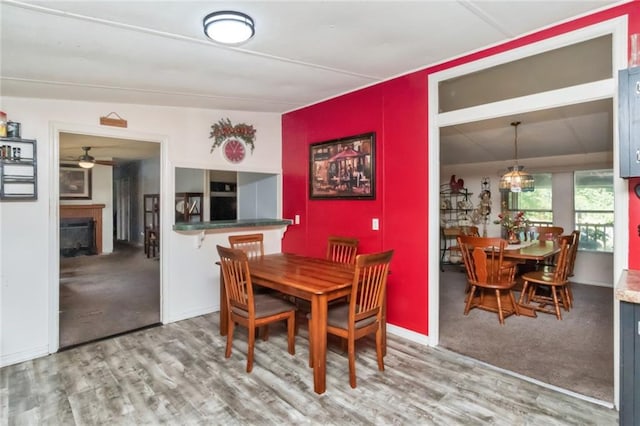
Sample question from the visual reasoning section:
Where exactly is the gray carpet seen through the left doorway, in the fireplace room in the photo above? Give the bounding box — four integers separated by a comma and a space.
60, 243, 160, 348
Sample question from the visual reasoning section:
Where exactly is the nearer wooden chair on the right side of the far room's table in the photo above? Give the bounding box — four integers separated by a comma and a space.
519, 240, 573, 320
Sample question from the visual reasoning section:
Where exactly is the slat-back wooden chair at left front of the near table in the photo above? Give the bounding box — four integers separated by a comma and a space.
217, 245, 296, 373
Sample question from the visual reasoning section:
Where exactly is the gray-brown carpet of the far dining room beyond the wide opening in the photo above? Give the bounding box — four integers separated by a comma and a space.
440, 267, 614, 402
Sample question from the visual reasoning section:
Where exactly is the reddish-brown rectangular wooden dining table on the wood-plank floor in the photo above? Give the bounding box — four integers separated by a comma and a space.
220, 253, 360, 394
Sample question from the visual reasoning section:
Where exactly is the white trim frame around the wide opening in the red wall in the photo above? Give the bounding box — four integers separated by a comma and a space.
428, 15, 629, 407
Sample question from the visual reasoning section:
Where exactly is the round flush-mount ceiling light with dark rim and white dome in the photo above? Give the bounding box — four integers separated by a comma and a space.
202, 10, 255, 44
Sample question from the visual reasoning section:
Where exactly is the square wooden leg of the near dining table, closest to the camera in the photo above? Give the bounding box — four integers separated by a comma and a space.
309, 294, 327, 394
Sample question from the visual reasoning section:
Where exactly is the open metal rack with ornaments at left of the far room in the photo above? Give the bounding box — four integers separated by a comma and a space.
440, 185, 474, 270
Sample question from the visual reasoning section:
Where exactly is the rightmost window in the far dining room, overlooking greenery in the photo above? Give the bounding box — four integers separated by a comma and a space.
573, 170, 614, 252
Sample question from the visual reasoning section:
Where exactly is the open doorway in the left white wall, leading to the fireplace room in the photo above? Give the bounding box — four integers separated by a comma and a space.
56, 132, 161, 348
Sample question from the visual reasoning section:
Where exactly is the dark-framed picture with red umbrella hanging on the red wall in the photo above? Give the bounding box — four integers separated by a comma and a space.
309, 132, 376, 200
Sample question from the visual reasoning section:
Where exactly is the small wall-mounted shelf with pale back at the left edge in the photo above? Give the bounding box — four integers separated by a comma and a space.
0, 138, 38, 201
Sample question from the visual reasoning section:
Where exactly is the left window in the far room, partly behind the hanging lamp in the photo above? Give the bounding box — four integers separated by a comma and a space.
505, 173, 553, 225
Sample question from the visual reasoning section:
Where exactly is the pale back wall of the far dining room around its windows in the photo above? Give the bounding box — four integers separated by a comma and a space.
440, 153, 614, 287
